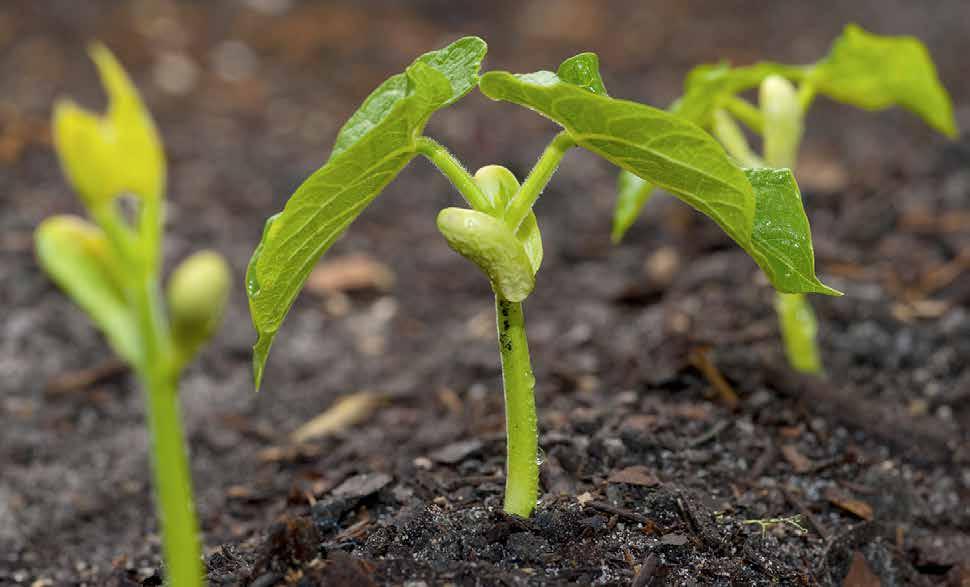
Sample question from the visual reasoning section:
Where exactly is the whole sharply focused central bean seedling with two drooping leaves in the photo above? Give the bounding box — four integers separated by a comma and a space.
247, 37, 837, 516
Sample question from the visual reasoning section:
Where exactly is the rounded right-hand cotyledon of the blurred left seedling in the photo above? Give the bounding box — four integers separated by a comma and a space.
167, 251, 231, 359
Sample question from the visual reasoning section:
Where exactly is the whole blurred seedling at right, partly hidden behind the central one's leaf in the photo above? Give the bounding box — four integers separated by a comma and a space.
613, 25, 957, 374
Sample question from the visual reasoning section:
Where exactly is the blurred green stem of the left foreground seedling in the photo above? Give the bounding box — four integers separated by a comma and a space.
133, 275, 203, 587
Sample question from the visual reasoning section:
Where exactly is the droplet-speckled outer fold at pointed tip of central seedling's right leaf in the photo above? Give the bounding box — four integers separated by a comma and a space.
745, 169, 842, 295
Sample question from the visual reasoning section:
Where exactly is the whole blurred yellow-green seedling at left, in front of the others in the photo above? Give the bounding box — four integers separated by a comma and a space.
36, 45, 230, 587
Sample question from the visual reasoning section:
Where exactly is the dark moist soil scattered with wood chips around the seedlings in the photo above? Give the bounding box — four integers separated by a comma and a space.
0, 0, 970, 587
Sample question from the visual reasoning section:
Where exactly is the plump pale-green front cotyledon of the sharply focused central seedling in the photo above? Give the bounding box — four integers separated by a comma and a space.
438, 208, 536, 302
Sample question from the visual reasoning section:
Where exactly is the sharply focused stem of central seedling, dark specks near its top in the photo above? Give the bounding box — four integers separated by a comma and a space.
495, 296, 539, 518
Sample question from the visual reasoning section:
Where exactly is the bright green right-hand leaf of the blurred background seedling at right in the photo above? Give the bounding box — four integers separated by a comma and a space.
812, 25, 957, 138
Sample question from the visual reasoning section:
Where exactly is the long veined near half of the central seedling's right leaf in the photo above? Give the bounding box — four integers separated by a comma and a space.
479, 71, 755, 246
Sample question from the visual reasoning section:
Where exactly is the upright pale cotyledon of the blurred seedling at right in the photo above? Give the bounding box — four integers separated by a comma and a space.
758, 75, 803, 169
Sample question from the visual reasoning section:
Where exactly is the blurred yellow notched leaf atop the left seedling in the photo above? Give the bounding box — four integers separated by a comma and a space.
53, 45, 165, 211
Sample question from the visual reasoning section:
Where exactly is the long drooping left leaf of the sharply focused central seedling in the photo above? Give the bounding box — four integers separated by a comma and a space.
246, 37, 485, 388
